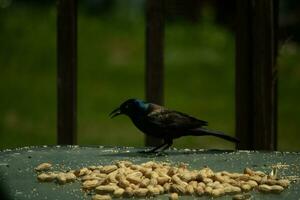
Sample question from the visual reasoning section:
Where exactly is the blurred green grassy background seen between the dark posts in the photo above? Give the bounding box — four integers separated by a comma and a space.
0, 0, 300, 151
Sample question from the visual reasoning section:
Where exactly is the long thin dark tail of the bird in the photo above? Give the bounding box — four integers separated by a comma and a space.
187, 128, 240, 143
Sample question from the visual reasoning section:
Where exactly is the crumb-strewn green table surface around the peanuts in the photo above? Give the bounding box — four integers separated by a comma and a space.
0, 146, 300, 200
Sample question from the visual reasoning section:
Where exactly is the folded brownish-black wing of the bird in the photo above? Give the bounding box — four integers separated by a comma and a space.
147, 109, 207, 129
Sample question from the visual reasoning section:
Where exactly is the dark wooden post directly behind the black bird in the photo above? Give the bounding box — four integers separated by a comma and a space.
145, 0, 165, 146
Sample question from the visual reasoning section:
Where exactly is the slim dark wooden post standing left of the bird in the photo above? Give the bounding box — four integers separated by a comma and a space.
57, 0, 77, 144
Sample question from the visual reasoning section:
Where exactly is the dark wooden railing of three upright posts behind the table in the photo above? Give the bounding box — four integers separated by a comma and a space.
57, 0, 278, 150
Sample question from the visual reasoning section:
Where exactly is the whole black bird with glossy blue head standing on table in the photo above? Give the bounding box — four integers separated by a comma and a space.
110, 99, 238, 152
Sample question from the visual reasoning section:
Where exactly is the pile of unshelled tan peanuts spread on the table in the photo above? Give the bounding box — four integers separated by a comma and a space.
36, 161, 290, 200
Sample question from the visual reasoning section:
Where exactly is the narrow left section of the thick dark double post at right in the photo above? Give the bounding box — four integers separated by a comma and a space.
235, 0, 254, 149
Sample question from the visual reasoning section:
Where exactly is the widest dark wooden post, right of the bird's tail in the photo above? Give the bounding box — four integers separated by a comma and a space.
236, 0, 278, 150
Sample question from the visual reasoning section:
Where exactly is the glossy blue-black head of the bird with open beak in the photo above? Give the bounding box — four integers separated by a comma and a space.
110, 99, 149, 118
